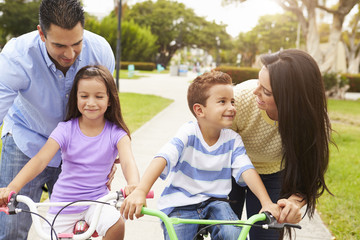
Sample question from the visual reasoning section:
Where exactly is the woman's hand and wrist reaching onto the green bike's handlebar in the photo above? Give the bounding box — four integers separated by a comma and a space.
277, 194, 306, 223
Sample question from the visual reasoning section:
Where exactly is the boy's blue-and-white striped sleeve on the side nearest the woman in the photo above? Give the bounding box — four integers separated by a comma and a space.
231, 132, 254, 186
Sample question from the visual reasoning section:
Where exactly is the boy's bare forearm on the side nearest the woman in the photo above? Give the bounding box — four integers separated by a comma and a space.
242, 169, 280, 219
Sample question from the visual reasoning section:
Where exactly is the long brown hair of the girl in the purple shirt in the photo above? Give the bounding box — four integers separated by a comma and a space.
65, 65, 130, 137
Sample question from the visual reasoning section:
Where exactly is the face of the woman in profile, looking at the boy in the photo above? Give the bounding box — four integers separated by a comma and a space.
254, 67, 278, 120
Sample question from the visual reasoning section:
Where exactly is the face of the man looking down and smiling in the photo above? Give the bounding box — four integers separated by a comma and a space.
38, 22, 84, 73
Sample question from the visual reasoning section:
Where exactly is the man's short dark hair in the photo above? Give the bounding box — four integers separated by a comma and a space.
39, 0, 85, 37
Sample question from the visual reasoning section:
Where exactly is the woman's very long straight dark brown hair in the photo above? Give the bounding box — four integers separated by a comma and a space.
261, 49, 332, 217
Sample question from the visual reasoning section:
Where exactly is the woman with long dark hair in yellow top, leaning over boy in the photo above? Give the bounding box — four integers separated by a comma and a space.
229, 49, 332, 240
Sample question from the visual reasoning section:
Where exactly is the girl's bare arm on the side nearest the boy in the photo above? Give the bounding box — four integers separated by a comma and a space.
117, 135, 140, 195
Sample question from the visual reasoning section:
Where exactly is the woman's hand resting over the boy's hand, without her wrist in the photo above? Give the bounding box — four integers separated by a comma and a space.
277, 199, 301, 224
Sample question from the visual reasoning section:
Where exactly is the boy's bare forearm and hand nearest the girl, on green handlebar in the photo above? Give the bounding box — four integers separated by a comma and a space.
120, 157, 166, 220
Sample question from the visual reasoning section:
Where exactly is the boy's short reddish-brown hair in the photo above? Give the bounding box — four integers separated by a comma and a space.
187, 71, 232, 117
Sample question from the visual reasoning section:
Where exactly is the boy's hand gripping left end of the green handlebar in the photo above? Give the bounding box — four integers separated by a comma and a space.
120, 188, 147, 220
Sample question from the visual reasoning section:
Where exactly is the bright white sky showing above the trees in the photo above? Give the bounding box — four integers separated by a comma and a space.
83, 0, 283, 37
